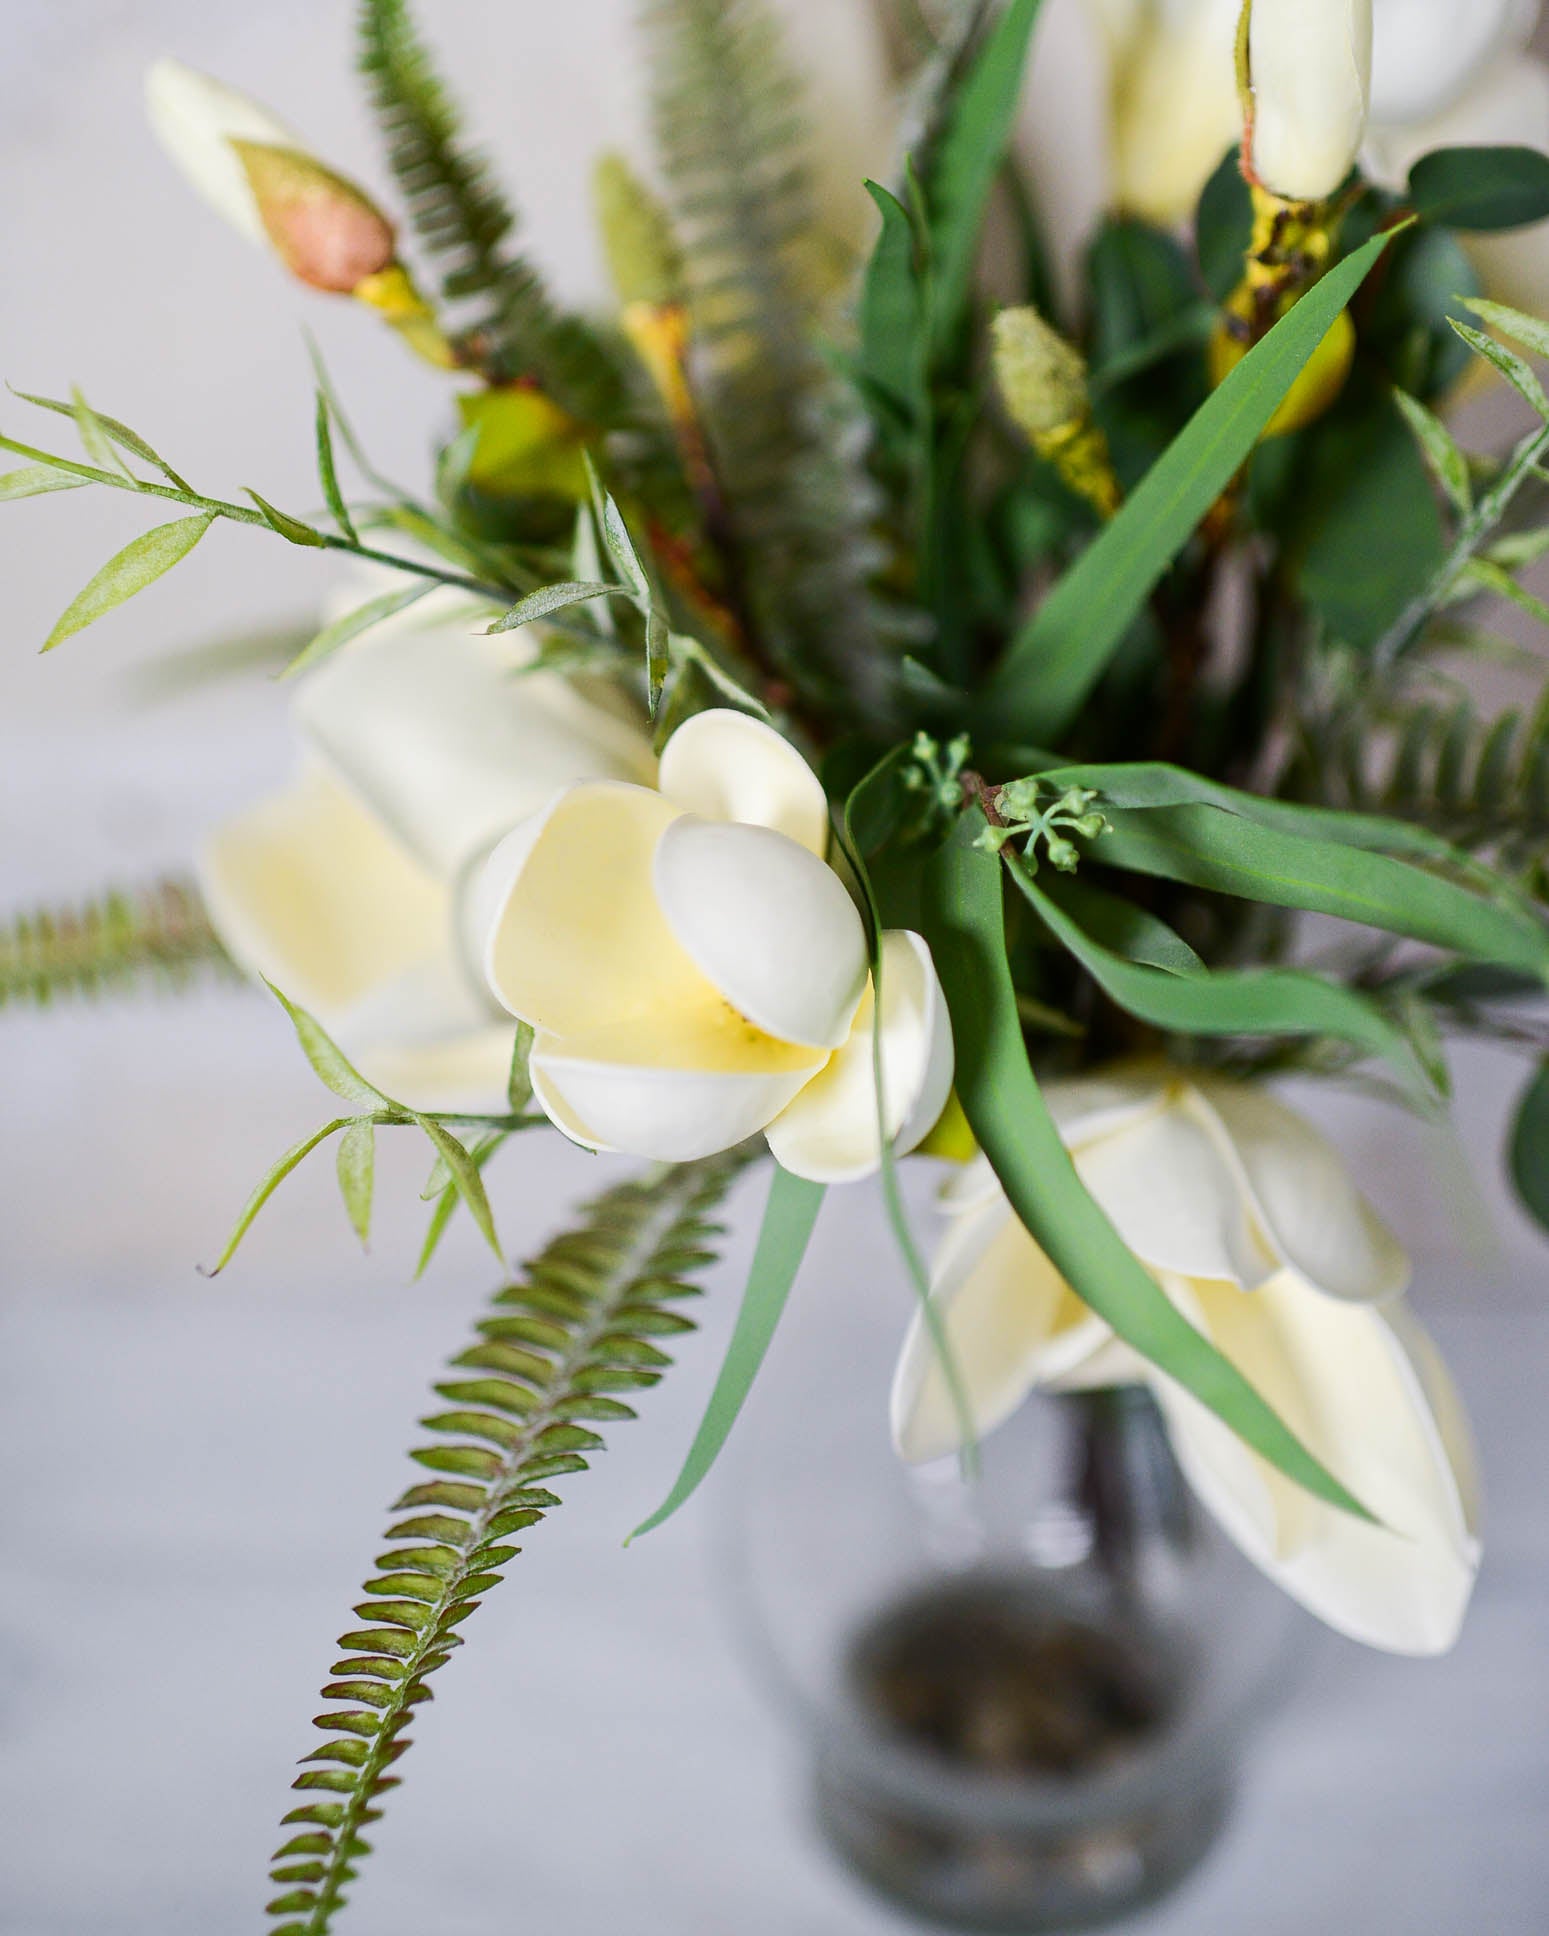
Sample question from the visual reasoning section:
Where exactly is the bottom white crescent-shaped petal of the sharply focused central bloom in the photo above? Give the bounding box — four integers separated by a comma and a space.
531, 1036, 811, 1164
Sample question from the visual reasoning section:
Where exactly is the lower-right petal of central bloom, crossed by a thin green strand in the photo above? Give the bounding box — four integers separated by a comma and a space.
769, 929, 953, 1183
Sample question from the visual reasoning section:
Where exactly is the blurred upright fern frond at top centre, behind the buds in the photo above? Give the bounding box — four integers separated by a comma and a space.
641, 0, 881, 711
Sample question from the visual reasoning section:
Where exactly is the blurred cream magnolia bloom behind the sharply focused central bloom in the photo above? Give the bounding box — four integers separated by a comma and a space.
199, 592, 656, 1111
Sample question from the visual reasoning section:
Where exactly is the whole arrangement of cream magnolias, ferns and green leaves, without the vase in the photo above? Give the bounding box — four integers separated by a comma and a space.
0, 0, 1549, 1936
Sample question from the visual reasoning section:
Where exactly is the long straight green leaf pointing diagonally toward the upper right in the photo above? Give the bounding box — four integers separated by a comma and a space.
980, 228, 1400, 741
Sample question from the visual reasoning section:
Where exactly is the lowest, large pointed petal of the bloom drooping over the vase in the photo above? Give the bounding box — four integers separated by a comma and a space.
1158, 1272, 1479, 1653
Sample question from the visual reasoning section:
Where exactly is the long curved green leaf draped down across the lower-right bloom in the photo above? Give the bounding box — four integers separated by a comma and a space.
926, 813, 1371, 1520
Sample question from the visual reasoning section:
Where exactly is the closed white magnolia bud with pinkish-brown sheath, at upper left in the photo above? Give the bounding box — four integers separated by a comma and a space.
145, 60, 395, 294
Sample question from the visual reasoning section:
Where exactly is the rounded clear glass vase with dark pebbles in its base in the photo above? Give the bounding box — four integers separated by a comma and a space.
720, 1277, 1305, 1936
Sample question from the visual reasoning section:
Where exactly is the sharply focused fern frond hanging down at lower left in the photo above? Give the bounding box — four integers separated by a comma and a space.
269, 1154, 744, 1936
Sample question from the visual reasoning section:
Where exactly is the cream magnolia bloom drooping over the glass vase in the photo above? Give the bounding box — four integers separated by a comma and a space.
893, 1069, 1479, 1653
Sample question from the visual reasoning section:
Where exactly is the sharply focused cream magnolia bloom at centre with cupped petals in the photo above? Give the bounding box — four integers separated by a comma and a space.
471, 709, 953, 1183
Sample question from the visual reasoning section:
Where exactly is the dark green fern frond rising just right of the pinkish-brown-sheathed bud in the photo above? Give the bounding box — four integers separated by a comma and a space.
360, 0, 627, 424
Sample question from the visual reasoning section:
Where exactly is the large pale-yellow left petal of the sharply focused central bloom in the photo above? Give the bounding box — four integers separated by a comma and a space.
478, 780, 714, 1036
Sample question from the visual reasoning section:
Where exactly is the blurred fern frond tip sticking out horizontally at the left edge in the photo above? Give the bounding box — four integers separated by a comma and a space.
0, 881, 236, 1009
